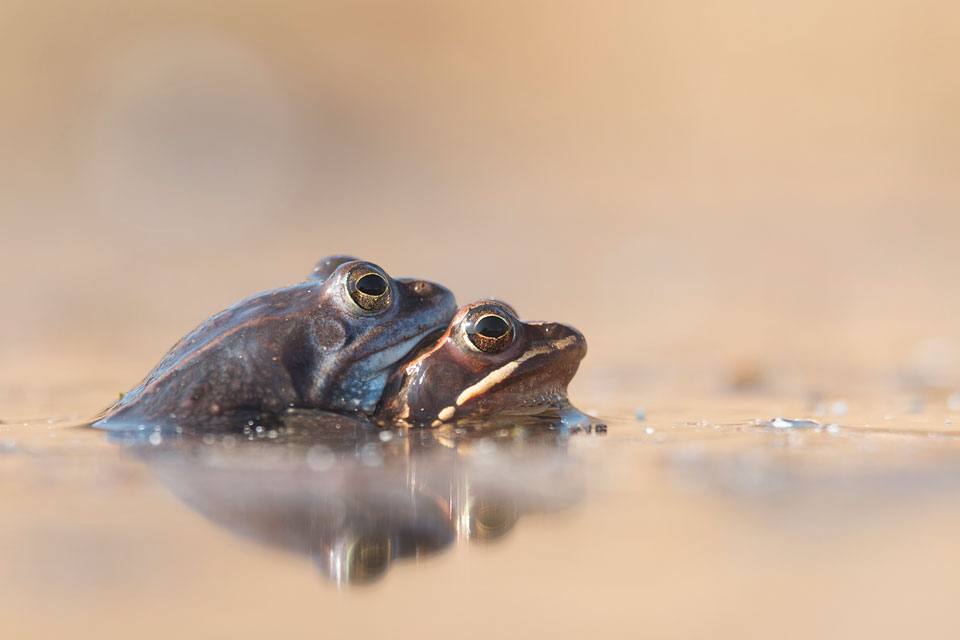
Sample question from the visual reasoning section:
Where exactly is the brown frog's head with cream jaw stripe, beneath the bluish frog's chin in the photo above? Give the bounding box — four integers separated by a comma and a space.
379, 300, 587, 423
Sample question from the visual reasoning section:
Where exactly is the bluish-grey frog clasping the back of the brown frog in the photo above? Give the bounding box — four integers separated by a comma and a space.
93, 255, 457, 430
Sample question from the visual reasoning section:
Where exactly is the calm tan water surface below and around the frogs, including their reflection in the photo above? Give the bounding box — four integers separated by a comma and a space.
0, 382, 960, 638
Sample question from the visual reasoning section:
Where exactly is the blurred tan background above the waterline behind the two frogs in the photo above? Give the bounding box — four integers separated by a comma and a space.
0, 0, 960, 414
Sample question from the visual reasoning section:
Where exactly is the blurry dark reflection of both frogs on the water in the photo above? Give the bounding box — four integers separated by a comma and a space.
109, 412, 591, 585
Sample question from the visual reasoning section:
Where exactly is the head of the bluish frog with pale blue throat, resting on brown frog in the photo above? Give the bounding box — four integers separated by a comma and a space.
303, 256, 457, 413
